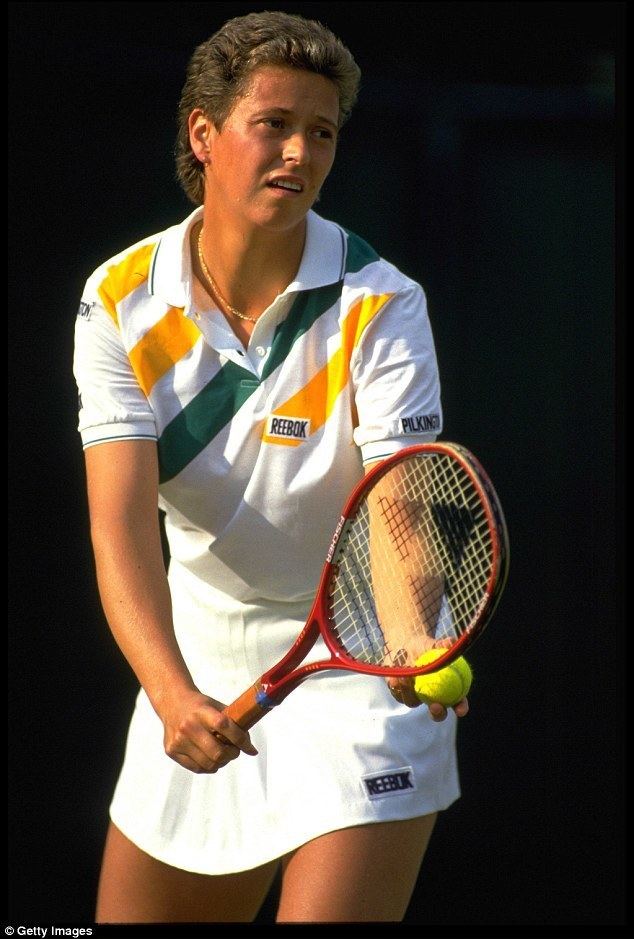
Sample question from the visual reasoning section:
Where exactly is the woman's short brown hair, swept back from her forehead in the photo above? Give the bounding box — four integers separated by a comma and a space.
176, 11, 361, 205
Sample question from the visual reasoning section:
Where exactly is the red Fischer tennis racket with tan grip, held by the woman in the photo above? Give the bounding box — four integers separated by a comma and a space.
220, 442, 509, 730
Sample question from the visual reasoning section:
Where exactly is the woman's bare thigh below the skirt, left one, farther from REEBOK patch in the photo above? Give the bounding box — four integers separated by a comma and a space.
96, 824, 278, 923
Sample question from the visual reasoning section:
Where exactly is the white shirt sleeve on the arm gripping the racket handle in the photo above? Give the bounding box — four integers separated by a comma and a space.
73, 298, 157, 448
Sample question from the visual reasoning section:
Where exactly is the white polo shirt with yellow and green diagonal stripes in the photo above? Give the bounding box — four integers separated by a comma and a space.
74, 209, 442, 602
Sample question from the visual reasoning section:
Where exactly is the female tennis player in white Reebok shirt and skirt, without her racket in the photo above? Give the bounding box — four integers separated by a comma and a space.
74, 12, 468, 923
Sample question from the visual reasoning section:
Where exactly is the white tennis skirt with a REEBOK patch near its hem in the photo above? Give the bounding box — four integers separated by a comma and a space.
110, 563, 460, 874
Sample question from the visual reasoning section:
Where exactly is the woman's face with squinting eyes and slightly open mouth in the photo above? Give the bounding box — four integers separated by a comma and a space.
203, 66, 339, 232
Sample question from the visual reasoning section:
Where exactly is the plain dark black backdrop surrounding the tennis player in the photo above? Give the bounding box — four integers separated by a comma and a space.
8, 2, 626, 936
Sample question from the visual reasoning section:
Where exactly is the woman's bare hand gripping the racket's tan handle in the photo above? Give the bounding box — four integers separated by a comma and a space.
160, 691, 258, 773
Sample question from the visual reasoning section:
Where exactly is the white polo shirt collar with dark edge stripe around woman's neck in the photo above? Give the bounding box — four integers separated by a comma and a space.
149, 206, 347, 312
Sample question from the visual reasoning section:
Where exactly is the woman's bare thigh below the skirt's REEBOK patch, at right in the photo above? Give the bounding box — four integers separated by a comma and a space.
277, 814, 436, 923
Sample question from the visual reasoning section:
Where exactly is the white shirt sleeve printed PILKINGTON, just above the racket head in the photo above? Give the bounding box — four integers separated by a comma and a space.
351, 282, 442, 463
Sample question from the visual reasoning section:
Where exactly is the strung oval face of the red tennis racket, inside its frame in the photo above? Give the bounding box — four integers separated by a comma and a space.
330, 454, 494, 667
